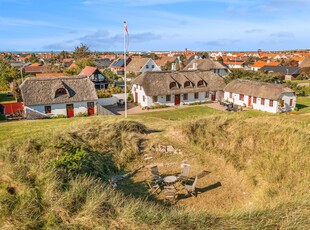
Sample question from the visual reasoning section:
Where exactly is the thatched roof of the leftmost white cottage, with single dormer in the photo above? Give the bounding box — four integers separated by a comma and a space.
20, 76, 98, 106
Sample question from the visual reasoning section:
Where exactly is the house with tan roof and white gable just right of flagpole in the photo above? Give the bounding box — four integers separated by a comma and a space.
126, 58, 161, 74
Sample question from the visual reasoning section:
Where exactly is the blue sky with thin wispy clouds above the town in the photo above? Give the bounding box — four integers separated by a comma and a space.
0, 0, 310, 51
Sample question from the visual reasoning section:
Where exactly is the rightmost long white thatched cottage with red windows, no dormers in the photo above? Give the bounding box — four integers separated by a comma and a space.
224, 79, 296, 113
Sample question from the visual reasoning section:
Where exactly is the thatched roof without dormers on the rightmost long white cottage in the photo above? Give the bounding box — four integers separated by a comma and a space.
224, 79, 294, 100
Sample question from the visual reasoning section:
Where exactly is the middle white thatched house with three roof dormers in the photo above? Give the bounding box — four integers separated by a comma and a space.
132, 70, 225, 107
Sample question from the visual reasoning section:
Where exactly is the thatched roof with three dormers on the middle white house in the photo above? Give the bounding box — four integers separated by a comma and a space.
133, 70, 225, 96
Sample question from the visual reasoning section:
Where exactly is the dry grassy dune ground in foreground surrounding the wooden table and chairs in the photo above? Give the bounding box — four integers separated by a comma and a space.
0, 104, 310, 229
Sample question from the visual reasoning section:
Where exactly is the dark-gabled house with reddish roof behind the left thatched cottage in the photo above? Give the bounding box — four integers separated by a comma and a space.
79, 66, 109, 90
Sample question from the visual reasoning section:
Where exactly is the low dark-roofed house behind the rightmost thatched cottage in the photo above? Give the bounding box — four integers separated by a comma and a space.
260, 65, 301, 80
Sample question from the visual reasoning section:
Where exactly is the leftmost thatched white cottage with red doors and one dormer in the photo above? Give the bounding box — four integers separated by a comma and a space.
20, 76, 98, 119
